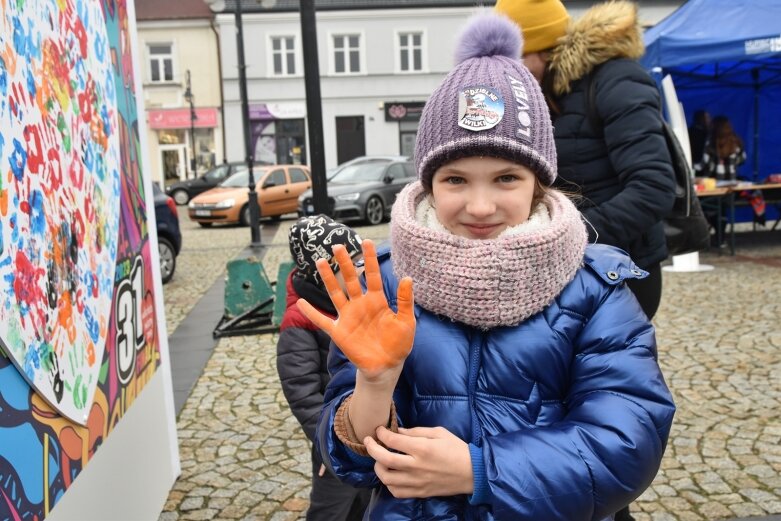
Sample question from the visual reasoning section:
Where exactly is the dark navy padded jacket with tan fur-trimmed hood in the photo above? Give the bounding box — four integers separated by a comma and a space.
550, 2, 675, 268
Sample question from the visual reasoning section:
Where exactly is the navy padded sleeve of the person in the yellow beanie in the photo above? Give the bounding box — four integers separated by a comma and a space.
583, 60, 675, 245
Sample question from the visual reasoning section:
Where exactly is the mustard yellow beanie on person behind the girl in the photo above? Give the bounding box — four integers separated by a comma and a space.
494, 0, 569, 53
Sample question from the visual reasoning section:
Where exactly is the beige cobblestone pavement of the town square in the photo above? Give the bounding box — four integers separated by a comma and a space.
160, 216, 781, 521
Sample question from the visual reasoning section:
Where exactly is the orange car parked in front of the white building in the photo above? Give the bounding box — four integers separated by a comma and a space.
187, 165, 312, 226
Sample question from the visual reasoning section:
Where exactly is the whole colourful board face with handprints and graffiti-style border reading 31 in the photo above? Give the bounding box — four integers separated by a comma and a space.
0, 0, 160, 520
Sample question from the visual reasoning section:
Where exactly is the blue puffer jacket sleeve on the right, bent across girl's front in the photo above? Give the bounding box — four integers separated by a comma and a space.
482, 285, 675, 521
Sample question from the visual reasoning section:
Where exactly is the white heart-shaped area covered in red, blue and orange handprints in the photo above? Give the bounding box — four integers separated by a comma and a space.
0, 2, 120, 424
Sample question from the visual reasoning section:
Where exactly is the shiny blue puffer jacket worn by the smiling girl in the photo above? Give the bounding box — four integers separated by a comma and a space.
317, 245, 675, 521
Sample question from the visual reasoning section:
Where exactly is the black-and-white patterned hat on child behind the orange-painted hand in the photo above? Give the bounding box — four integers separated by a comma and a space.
288, 214, 363, 284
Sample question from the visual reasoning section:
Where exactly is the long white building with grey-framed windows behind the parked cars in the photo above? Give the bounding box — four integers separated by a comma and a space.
206, 0, 681, 168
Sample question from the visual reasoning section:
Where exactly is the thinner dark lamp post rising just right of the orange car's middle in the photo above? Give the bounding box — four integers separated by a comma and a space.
207, 0, 261, 248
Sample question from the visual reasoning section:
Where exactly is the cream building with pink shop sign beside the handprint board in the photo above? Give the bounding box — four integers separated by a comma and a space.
136, 0, 224, 186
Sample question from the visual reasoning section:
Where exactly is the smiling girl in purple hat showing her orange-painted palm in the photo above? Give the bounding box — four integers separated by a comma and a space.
299, 14, 675, 521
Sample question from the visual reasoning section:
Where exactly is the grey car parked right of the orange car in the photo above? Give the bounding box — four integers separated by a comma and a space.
298, 161, 415, 224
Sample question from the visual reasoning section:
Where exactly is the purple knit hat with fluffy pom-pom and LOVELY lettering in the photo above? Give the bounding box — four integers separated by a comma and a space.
415, 13, 556, 187
